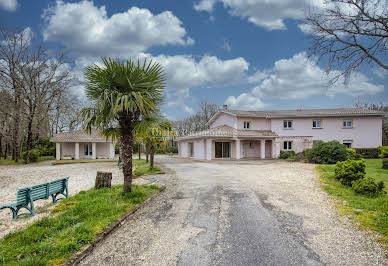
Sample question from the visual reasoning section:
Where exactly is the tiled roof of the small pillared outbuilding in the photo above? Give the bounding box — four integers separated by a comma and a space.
50, 130, 112, 142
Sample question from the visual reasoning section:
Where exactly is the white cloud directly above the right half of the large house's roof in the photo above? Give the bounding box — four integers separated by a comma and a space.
226, 53, 384, 109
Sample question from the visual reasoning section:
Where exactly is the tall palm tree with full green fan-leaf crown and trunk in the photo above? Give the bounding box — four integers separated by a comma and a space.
82, 58, 166, 192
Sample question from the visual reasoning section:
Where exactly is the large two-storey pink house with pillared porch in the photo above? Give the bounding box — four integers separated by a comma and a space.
178, 106, 384, 160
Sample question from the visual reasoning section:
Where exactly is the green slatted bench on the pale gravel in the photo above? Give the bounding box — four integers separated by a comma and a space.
0, 176, 69, 219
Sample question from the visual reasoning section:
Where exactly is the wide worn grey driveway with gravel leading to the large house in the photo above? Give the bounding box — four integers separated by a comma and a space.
83, 157, 387, 265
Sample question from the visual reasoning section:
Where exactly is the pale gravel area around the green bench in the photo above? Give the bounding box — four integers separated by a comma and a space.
0, 161, 150, 238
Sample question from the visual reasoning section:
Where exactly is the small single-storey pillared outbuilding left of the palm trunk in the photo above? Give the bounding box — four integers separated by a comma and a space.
50, 130, 115, 160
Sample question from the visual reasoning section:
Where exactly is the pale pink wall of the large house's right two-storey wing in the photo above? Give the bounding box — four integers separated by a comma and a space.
271, 117, 382, 148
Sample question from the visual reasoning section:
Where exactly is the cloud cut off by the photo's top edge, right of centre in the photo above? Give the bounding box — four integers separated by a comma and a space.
194, 0, 322, 30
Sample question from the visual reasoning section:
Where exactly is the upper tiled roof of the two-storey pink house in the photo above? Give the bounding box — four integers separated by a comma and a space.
222, 108, 384, 118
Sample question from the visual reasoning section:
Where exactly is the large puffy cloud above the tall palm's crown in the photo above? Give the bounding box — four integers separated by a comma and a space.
42, 0, 194, 56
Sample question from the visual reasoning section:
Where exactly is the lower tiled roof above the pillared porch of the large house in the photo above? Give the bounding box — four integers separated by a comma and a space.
178, 125, 277, 140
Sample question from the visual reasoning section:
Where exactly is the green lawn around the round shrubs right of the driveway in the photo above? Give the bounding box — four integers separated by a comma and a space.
317, 159, 388, 247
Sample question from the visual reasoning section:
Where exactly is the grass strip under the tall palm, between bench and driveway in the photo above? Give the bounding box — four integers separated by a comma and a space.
0, 185, 159, 265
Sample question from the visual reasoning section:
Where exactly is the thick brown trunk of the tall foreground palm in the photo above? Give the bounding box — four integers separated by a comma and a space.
119, 119, 134, 193
